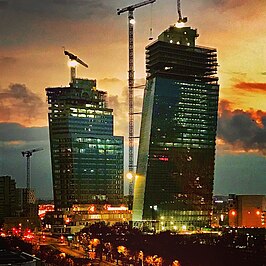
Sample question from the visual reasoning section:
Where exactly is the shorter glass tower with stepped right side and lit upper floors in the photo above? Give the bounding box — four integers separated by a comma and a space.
46, 79, 124, 210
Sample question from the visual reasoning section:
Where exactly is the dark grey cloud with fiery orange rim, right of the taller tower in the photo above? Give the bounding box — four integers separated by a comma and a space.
218, 101, 266, 155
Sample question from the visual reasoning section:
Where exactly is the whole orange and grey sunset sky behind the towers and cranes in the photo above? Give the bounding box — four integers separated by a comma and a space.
0, 0, 266, 198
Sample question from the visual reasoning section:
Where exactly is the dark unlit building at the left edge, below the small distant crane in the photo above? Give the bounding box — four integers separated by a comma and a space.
0, 176, 17, 222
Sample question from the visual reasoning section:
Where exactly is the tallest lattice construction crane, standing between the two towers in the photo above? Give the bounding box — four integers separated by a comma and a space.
117, 0, 156, 196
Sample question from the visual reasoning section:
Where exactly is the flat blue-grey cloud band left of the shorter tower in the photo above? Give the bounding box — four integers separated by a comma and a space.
0, 123, 49, 142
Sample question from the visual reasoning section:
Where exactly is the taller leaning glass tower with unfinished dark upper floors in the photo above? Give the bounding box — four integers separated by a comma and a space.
133, 26, 219, 230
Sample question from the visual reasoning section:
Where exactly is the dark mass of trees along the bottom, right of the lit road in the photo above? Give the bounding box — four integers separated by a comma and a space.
79, 223, 266, 266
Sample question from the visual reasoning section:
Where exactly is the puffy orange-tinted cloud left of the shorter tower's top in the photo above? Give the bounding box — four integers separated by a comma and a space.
0, 84, 47, 125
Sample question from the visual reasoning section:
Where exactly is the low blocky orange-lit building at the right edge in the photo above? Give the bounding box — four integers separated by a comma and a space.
228, 194, 266, 228
